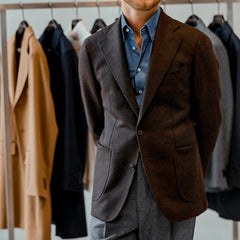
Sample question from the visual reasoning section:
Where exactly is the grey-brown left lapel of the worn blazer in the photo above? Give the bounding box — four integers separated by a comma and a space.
99, 18, 138, 117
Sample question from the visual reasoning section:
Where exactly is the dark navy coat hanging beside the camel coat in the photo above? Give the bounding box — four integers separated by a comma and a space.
40, 25, 87, 238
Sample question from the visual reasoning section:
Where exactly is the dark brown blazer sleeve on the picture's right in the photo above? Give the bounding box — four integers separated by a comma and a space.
193, 35, 222, 174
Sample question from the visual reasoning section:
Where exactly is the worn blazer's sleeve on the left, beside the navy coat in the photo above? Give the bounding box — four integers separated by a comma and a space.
79, 39, 104, 144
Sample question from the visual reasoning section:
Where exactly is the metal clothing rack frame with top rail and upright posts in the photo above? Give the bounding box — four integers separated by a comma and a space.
0, 0, 240, 240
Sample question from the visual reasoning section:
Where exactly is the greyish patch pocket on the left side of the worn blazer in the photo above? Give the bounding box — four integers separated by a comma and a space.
92, 143, 112, 201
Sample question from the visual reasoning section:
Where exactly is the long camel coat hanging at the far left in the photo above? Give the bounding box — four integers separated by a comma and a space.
0, 26, 58, 240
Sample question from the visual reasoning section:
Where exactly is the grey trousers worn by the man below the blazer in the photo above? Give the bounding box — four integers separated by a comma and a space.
90, 158, 196, 240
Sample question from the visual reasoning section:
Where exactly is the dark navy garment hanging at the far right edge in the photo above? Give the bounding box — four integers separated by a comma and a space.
209, 22, 240, 188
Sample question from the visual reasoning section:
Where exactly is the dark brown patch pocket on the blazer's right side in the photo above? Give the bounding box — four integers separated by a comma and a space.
174, 143, 205, 201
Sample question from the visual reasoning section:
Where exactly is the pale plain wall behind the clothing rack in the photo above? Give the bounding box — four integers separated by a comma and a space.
0, 0, 240, 240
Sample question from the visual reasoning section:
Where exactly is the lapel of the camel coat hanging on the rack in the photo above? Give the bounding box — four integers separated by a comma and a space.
14, 27, 34, 106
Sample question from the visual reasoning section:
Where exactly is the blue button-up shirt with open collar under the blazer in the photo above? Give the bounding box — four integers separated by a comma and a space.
121, 8, 161, 109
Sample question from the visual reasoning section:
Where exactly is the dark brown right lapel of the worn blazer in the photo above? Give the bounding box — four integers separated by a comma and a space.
138, 9, 182, 122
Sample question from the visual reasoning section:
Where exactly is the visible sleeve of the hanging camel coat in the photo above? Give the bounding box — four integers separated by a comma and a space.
25, 49, 58, 198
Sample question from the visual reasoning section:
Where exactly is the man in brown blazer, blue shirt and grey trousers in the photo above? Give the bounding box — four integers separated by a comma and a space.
79, 0, 221, 240
